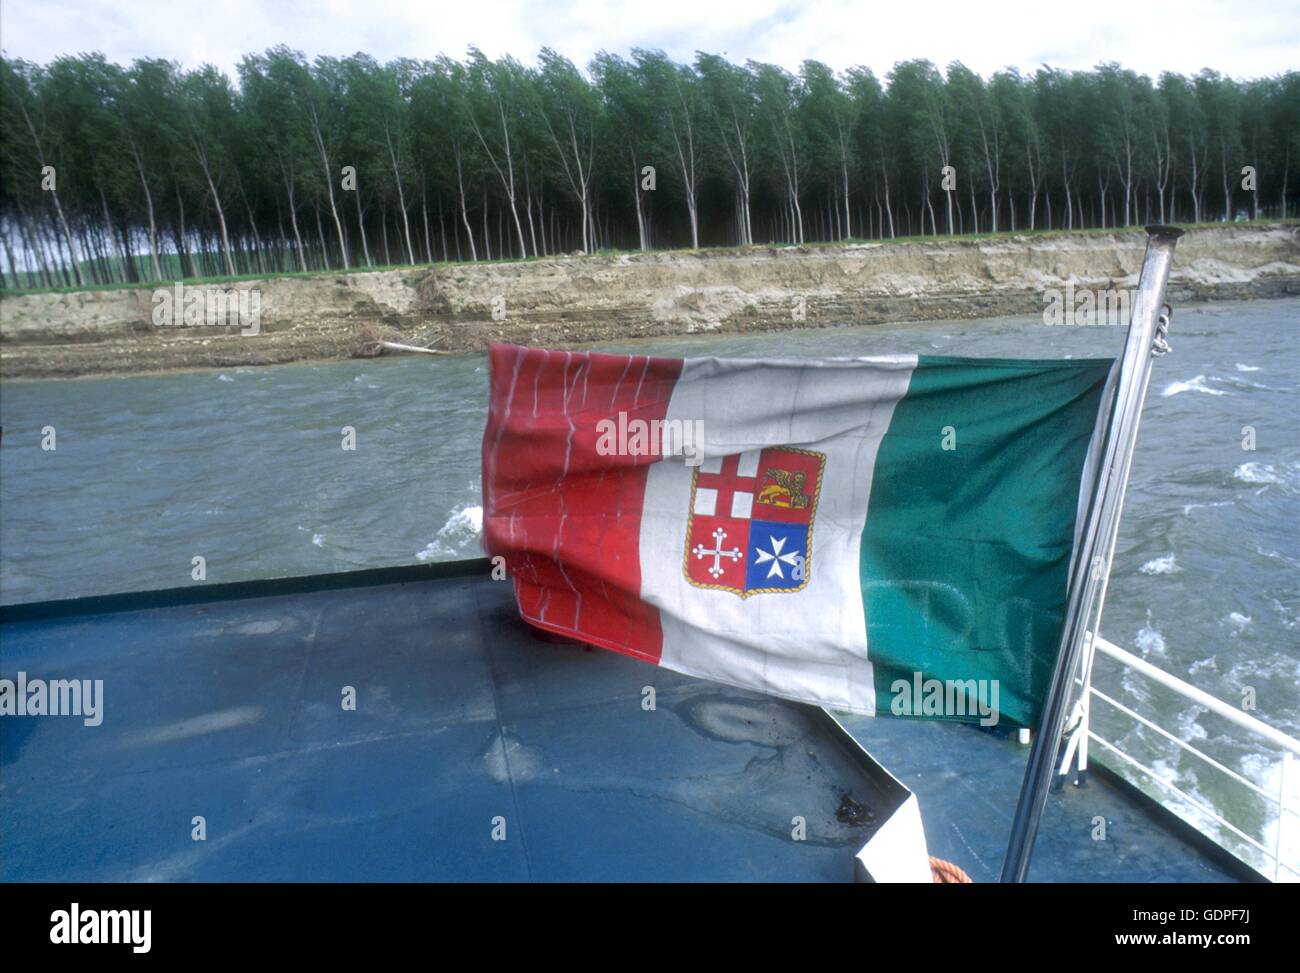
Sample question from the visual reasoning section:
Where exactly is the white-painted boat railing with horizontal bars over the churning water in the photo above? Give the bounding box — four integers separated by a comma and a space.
1061, 632, 1300, 882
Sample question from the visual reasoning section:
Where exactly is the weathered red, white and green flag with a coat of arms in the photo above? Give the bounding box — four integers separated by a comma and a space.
482, 345, 1114, 726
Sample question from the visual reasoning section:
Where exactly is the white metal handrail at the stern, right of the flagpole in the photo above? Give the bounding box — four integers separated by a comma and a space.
1061, 632, 1300, 881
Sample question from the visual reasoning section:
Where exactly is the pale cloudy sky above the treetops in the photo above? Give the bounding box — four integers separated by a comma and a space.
0, 0, 1300, 78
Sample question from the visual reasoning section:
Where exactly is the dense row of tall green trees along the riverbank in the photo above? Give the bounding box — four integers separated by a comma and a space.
0, 47, 1300, 286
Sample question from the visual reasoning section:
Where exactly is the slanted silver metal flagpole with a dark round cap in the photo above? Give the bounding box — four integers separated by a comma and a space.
1002, 226, 1183, 882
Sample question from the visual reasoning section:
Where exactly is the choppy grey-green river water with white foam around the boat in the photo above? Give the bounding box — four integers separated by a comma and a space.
0, 293, 1300, 868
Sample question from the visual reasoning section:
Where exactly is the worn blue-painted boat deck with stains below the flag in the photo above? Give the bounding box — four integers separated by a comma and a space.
0, 561, 1230, 881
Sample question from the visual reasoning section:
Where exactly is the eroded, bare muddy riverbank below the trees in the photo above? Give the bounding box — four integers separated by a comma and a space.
0, 225, 1300, 379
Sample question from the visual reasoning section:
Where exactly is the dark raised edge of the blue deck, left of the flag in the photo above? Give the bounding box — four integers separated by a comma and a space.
0, 558, 491, 624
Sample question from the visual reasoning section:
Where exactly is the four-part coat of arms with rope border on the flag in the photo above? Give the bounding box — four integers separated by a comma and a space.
684, 446, 826, 598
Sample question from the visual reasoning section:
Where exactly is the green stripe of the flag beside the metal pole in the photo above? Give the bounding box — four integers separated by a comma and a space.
861, 356, 1113, 726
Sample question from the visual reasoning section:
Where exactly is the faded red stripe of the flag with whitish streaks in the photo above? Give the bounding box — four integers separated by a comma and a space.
484, 345, 683, 663
